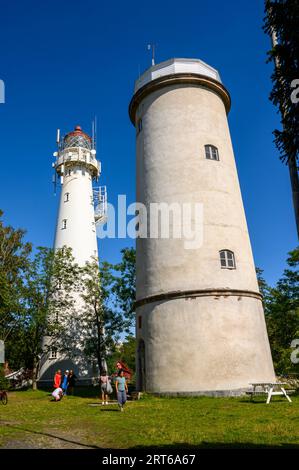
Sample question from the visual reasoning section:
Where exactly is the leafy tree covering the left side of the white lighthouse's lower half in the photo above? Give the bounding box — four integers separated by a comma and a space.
19, 247, 79, 389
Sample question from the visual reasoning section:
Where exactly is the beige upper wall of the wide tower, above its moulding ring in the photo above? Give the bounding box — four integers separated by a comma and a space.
137, 86, 258, 298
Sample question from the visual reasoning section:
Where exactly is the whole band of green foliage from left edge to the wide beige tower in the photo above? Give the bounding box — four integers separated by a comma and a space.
0, 215, 135, 386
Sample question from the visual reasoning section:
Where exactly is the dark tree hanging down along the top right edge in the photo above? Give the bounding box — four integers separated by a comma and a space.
264, 0, 299, 236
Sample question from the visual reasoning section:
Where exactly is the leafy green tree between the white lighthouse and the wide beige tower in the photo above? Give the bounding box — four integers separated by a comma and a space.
80, 248, 136, 370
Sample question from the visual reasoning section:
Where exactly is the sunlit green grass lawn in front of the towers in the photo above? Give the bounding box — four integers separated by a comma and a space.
0, 390, 299, 448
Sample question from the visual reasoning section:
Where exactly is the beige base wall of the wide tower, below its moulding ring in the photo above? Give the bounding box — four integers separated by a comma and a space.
137, 296, 274, 394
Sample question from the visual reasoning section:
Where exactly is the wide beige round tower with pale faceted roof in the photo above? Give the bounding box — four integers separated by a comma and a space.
129, 59, 275, 395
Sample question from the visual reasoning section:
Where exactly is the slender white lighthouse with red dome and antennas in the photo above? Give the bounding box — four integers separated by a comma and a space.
39, 126, 107, 382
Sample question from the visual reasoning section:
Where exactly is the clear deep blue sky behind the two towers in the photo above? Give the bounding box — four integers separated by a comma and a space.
0, 0, 297, 285
